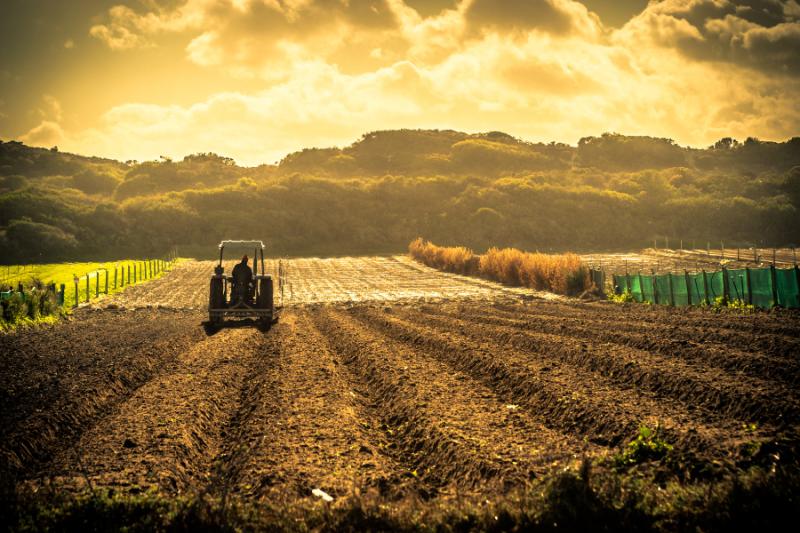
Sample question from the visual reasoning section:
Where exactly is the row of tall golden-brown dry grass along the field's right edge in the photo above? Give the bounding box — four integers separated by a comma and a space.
408, 238, 591, 295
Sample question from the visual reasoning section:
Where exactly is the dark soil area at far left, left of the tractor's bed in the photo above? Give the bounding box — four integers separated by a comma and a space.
0, 311, 203, 482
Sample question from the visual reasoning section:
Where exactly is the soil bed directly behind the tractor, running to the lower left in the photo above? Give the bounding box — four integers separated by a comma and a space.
30, 328, 263, 494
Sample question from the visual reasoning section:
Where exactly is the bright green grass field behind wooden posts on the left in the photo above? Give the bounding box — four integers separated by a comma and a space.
0, 260, 173, 309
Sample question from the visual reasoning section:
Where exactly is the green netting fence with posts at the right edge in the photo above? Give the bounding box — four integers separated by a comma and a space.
612, 267, 800, 309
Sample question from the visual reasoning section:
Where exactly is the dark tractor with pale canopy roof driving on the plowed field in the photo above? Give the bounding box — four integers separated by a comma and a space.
208, 241, 277, 326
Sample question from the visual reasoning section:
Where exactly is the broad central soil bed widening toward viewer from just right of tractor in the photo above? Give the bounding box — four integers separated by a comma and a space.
211, 310, 428, 503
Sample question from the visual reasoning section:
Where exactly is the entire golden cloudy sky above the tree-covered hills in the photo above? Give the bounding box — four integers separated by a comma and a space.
0, 0, 800, 165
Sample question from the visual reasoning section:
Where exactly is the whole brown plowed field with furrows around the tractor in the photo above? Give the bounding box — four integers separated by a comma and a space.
0, 257, 800, 528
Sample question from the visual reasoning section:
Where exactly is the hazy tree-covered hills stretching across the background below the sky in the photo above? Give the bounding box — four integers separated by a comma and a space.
0, 130, 800, 262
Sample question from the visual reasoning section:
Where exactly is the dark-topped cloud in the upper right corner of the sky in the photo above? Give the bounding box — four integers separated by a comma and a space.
620, 0, 800, 75
